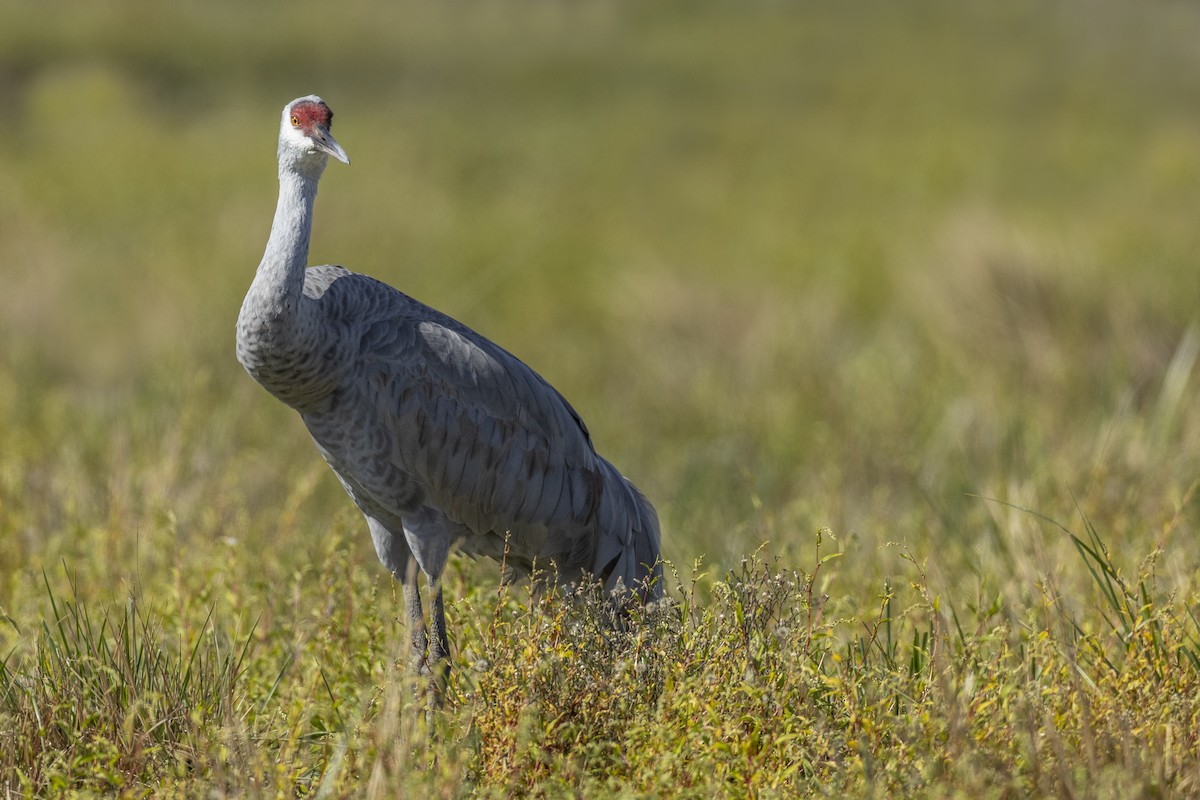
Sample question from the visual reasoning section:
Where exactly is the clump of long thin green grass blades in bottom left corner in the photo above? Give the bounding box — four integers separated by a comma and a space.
0, 573, 252, 792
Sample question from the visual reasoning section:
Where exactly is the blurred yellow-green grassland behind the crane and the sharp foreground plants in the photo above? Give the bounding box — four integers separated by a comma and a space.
0, 0, 1200, 608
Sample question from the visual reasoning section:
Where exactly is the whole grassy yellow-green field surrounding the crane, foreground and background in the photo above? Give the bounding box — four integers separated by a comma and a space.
0, 0, 1200, 799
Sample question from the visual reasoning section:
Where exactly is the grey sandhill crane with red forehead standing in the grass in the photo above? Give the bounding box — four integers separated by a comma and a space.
238, 95, 662, 670
